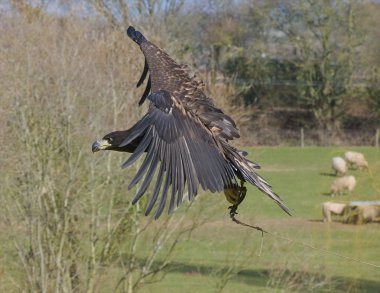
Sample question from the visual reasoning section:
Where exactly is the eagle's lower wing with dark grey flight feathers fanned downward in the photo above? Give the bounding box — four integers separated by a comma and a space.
119, 91, 235, 219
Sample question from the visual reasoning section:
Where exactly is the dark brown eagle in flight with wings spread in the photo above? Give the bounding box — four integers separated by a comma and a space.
92, 27, 290, 219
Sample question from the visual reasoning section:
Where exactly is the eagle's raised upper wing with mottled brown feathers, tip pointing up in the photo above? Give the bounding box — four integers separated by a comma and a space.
127, 27, 240, 140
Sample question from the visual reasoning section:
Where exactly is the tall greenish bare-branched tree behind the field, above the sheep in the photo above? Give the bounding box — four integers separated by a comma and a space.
275, 0, 357, 131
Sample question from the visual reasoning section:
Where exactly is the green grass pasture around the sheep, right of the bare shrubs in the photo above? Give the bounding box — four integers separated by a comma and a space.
137, 147, 380, 292
